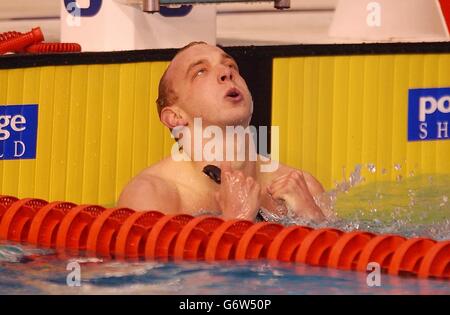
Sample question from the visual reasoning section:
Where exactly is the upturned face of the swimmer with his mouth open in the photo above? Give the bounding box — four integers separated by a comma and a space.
167, 44, 253, 126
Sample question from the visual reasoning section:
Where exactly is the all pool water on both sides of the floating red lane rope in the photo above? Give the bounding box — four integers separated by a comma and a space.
0, 168, 450, 295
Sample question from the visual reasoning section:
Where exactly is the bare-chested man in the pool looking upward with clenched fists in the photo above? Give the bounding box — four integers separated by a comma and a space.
118, 42, 325, 222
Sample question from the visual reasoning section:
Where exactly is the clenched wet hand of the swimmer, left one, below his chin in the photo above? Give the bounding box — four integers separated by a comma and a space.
216, 162, 261, 221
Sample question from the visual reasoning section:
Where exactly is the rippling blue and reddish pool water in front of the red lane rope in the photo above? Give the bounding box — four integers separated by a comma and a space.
0, 245, 450, 295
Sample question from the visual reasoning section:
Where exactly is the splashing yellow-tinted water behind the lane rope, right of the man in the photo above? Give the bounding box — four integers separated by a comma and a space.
258, 164, 450, 240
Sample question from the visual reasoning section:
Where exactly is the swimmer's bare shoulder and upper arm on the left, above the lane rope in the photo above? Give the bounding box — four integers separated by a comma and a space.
117, 175, 180, 214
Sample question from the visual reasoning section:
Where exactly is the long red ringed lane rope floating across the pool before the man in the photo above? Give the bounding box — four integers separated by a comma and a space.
0, 196, 450, 279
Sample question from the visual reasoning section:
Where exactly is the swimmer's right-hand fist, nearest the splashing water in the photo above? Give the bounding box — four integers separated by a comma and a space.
267, 170, 325, 222
